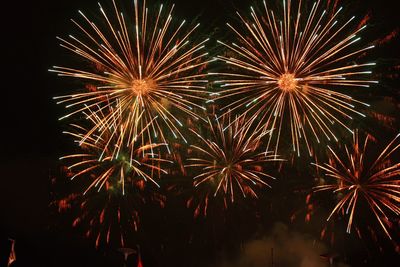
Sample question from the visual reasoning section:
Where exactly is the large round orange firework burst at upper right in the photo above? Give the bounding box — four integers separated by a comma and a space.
210, 0, 377, 155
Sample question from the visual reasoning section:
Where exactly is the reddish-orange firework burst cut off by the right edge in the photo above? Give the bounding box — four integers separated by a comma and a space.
314, 131, 400, 241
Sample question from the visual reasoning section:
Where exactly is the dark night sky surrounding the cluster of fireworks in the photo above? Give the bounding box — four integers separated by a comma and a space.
0, 0, 400, 267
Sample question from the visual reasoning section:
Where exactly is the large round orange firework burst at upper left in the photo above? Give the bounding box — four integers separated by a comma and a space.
50, 0, 212, 155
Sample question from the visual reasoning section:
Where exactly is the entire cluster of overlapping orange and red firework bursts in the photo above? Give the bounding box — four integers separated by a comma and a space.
50, 0, 400, 266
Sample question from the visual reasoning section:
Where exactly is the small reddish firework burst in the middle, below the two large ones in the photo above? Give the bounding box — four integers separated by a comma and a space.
185, 114, 282, 202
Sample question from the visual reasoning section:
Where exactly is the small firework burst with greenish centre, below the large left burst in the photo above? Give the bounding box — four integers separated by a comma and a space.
60, 107, 169, 195
